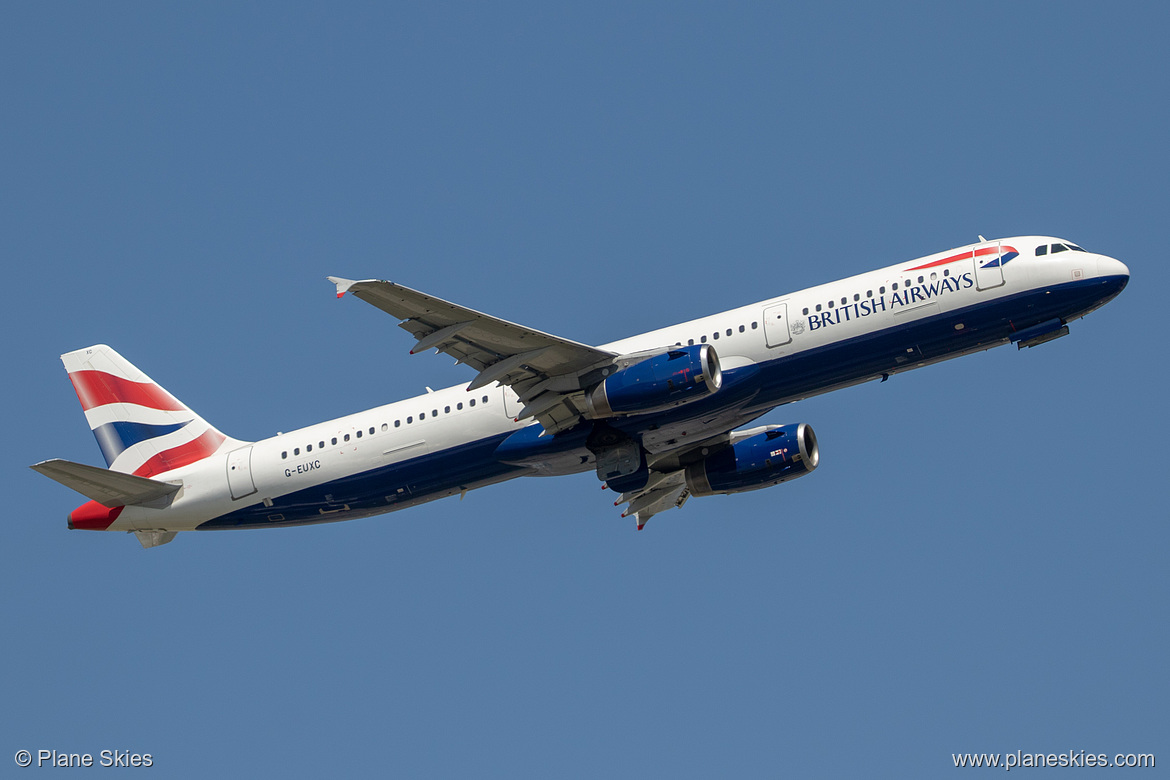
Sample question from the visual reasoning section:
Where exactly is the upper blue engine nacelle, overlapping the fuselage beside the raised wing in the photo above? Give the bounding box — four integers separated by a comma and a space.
585, 344, 723, 420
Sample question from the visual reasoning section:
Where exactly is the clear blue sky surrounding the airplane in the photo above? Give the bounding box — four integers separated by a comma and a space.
0, 2, 1170, 778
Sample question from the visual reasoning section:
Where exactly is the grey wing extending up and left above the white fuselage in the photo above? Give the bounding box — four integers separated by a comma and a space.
328, 276, 618, 433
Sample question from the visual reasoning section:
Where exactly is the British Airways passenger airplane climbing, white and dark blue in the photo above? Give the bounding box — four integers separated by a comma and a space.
30, 236, 1129, 547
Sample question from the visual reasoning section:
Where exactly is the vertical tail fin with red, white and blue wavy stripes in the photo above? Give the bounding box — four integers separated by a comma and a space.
61, 344, 234, 477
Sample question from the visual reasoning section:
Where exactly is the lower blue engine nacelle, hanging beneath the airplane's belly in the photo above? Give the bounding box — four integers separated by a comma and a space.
687, 422, 820, 496
